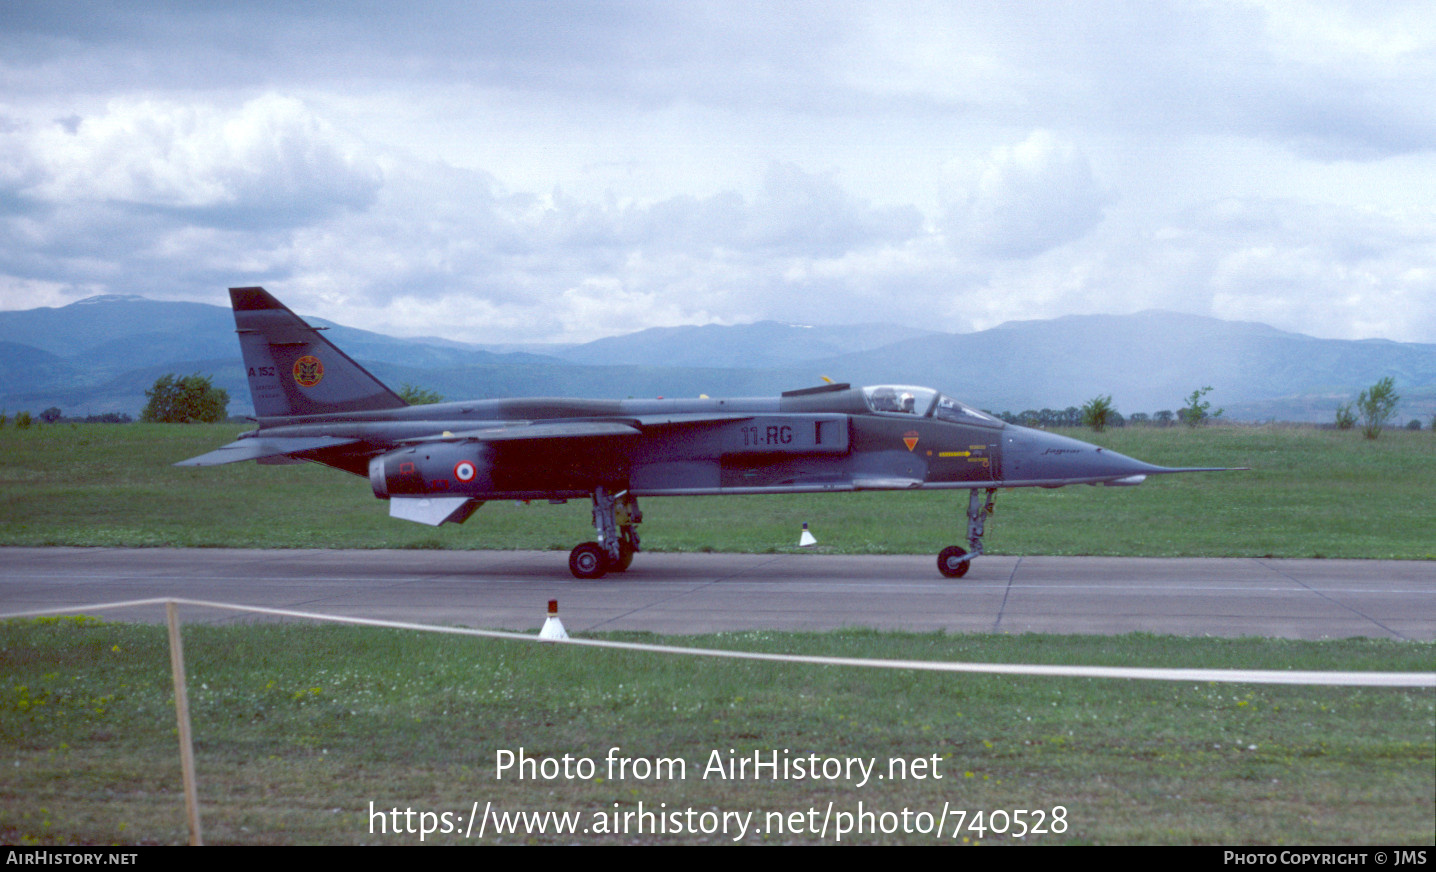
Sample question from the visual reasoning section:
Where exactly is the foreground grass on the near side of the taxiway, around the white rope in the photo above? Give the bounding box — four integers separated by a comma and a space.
0, 618, 1436, 845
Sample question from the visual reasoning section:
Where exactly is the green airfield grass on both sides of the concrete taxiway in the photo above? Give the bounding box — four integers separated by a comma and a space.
0, 425, 1436, 845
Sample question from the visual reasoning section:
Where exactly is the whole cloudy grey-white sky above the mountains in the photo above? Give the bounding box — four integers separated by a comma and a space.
0, 0, 1436, 342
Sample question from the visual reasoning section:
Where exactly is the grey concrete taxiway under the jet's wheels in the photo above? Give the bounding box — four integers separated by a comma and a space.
0, 547, 1436, 639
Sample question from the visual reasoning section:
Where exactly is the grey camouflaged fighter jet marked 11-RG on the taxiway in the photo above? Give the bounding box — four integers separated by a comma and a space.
175, 287, 1219, 579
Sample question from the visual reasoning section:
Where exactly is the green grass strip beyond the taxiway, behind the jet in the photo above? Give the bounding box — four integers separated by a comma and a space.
0, 424, 1436, 560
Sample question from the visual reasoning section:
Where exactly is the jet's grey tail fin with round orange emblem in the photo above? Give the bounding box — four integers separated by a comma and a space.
230, 287, 408, 418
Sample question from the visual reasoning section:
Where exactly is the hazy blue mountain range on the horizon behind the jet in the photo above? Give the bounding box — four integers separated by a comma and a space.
0, 294, 1436, 424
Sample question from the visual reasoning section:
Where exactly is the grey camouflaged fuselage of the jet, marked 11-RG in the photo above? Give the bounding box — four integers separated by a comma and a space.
235, 385, 1157, 500
